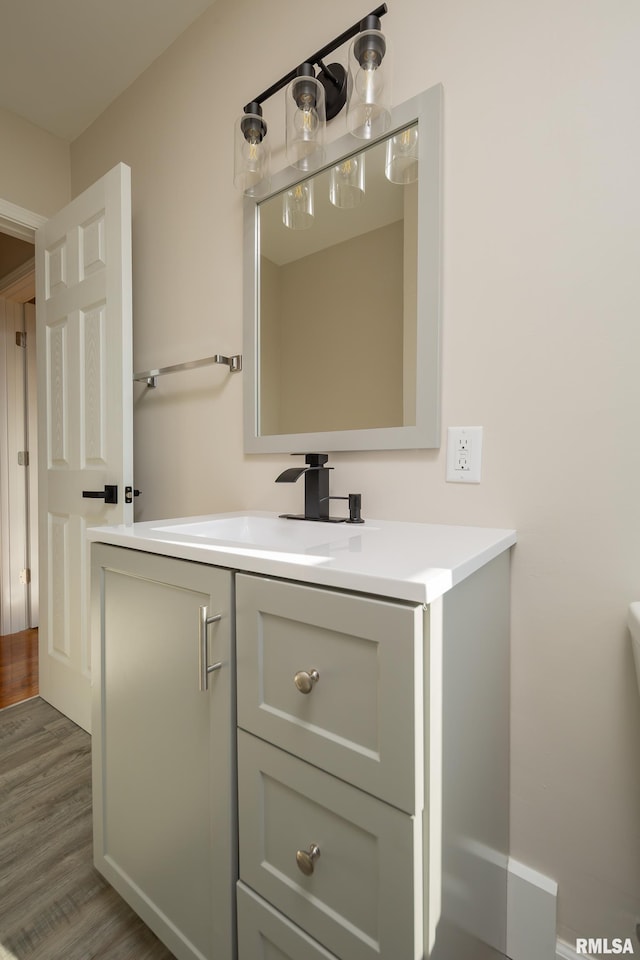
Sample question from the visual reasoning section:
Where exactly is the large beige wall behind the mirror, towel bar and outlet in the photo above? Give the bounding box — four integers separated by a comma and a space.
70, 0, 640, 940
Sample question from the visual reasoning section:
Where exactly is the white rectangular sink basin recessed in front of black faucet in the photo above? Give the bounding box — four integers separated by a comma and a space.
153, 515, 362, 554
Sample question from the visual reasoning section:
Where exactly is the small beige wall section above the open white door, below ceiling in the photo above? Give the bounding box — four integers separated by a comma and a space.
0, 107, 71, 217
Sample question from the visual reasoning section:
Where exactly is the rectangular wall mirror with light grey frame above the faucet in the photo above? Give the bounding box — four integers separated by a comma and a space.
243, 85, 442, 453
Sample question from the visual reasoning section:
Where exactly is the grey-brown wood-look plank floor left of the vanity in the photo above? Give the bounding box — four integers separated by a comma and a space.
0, 697, 173, 960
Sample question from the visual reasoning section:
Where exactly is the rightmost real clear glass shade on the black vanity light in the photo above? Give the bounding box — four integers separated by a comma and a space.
347, 30, 391, 140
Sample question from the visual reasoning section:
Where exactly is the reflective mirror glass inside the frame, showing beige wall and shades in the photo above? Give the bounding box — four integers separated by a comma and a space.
258, 123, 418, 436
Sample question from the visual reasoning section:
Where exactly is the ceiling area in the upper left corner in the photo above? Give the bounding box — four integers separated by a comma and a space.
0, 0, 214, 141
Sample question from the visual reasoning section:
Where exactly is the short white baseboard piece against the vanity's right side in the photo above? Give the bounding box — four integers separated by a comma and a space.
507, 857, 556, 960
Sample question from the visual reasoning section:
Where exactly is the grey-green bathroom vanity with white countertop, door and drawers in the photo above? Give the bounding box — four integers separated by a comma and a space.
89, 513, 515, 960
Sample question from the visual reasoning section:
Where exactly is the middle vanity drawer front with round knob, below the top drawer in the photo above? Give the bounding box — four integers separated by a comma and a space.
238, 730, 422, 960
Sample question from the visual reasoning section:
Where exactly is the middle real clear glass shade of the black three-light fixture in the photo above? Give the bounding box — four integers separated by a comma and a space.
285, 76, 326, 170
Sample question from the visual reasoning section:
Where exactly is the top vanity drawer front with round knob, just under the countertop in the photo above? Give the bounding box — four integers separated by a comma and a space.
236, 574, 424, 813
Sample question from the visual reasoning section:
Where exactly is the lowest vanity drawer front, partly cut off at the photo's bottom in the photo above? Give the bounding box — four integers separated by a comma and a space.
238, 883, 337, 960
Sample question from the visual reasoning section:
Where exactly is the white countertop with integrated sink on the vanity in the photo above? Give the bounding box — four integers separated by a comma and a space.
87, 511, 516, 603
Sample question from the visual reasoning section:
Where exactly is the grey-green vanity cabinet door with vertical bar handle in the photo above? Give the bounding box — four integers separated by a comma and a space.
93, 544, 235, 960
